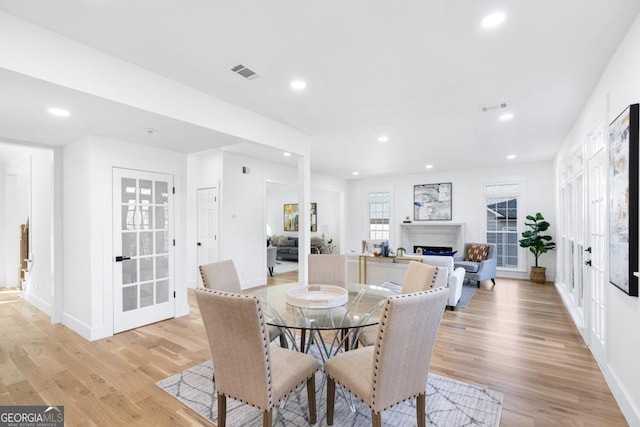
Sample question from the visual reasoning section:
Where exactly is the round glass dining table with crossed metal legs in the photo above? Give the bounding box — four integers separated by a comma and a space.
251, 283, 397, 361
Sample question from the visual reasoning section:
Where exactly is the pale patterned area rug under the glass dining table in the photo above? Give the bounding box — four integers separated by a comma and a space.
156, 361, 503, 427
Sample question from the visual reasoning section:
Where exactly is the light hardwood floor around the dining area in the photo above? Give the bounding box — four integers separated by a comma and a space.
0, 273, 627, 427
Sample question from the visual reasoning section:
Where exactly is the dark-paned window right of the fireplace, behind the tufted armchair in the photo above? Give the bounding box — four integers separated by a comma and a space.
485, 183, 520, 268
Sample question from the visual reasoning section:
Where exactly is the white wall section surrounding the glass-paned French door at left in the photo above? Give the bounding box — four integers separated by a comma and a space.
62, 137, 189, 340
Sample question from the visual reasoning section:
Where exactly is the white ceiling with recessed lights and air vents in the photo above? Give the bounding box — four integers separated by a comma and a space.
0, 0, 640, 178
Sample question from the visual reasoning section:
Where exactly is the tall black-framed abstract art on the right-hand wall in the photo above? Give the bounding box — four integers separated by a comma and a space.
609, 104, 640, 297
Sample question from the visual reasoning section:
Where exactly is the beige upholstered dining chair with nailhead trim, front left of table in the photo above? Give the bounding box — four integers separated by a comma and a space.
195, 289, 318, 427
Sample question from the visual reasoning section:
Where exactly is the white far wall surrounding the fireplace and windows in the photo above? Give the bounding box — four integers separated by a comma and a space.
344, 161, 557, 280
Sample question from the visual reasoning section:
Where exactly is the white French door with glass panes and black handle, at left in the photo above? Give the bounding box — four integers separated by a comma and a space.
113, 168, 175, 333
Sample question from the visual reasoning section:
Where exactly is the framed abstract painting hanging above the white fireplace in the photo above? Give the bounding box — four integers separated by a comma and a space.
413, 182, 451, 221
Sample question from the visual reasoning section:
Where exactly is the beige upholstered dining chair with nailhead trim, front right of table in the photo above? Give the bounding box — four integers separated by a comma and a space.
324, 288, 449, 427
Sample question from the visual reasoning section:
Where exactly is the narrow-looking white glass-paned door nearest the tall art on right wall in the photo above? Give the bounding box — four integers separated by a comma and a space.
585, 149, 608, 362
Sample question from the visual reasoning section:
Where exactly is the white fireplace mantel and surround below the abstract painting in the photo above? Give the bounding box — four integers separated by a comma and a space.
400, 221, 465, 252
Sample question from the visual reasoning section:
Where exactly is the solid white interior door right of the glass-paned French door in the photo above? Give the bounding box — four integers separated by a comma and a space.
196, 188, 219, 281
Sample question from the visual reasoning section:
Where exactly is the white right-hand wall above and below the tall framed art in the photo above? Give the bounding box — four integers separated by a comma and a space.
556, 17, 640, 426
